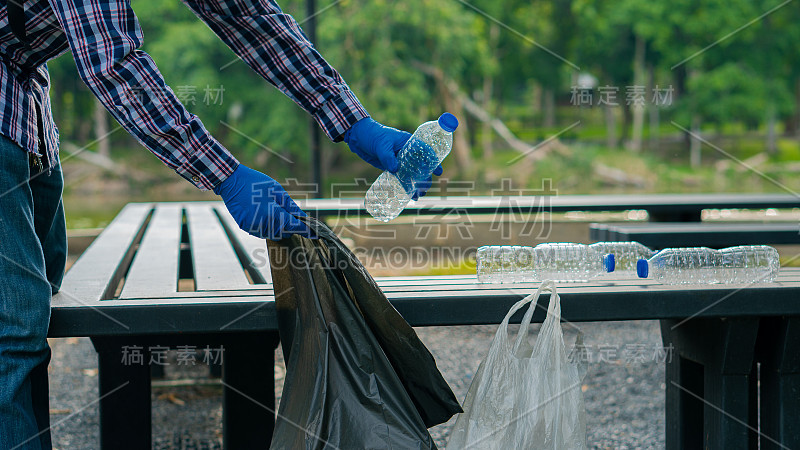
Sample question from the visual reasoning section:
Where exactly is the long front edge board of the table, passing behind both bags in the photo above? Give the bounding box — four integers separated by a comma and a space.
50, 269, 800, 337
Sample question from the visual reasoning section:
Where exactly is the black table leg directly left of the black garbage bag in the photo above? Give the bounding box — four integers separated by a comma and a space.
222, 333, 278, 450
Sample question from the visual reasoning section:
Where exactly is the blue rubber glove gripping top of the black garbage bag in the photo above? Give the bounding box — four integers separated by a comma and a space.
214, 164, 313, 240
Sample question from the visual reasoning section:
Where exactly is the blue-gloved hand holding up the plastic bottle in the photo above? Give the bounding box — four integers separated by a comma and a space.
344, 117, 443, 200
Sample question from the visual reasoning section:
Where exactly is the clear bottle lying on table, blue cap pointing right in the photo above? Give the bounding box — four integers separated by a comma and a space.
476, 242, 614, 283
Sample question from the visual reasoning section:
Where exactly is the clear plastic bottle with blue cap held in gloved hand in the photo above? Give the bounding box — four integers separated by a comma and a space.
364, 113, 458, 222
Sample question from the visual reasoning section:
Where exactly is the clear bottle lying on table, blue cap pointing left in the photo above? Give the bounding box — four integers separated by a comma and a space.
637, 245, 780, 284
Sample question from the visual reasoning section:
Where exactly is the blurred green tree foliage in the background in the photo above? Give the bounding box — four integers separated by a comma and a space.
49, 0, 800, 188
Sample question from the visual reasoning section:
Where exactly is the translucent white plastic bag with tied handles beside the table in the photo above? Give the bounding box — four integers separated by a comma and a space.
447, 281, 586, 450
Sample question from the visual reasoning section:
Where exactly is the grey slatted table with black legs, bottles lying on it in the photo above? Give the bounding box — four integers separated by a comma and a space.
50, 203, 800, 449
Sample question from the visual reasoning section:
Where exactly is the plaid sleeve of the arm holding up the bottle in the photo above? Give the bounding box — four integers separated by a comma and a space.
183, 0, 369, 142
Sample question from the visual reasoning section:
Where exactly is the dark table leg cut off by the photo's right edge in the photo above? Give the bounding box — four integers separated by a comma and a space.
758, 317, 800, 449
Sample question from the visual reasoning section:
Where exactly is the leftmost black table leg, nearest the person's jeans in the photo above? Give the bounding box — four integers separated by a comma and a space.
92, 338, 152, 450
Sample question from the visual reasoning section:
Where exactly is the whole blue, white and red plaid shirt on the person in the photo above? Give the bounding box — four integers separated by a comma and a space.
0, 0, 368, 189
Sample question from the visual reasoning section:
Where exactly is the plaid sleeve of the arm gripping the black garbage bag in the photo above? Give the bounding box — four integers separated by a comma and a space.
49, 0, 239, 190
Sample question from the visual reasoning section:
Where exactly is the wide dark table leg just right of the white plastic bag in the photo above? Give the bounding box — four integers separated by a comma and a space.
661, 318, 758, 449
